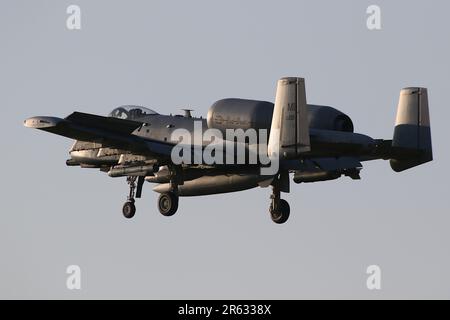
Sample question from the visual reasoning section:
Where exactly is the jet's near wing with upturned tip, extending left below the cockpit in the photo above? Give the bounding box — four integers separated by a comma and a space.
24, 112, 172, 157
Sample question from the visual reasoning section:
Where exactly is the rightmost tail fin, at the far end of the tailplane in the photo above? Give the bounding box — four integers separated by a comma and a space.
390, 88, 433, 172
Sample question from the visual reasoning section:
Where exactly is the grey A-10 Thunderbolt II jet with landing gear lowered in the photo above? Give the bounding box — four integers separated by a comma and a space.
24, 77, 433, 223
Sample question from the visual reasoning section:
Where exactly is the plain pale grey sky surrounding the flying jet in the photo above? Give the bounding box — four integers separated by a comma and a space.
0, 0, 450, 299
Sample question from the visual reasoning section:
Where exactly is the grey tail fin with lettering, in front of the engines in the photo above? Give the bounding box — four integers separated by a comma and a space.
268, 77, 310, 158
